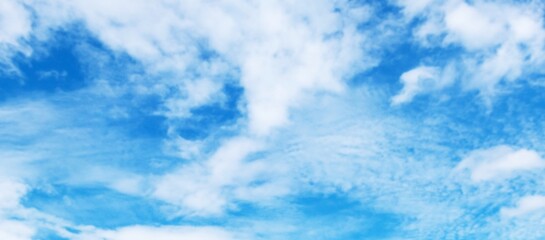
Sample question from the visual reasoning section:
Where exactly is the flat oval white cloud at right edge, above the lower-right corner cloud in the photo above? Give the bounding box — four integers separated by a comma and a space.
456, 145, 545, 182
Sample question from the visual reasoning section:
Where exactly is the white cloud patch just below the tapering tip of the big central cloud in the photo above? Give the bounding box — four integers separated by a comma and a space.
152, 137, 284, 216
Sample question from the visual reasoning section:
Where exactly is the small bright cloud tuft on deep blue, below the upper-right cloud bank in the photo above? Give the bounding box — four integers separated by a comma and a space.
392, 64, 455, 105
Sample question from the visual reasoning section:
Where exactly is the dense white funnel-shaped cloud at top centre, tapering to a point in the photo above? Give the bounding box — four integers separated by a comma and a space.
193, 1, 369, 134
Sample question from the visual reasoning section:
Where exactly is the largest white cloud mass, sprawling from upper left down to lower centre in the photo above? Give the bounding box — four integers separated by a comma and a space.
13, 0, 375, 214
